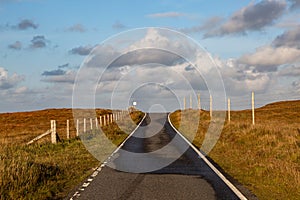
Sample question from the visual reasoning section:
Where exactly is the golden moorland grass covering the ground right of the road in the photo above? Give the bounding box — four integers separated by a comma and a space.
171, 101, 300, 200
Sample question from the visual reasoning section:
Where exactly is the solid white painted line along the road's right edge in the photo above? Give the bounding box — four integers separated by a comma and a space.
168, 113, 248, 200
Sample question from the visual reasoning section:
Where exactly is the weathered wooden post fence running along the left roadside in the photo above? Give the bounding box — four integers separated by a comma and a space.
27, 110, 129, 144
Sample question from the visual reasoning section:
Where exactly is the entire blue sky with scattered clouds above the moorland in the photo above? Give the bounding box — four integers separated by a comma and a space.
0, 0, 300, 112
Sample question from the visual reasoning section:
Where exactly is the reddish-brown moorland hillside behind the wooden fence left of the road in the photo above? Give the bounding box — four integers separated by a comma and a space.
0, 109, 112, 144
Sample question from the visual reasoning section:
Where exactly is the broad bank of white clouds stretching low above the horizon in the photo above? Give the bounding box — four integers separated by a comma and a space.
0, 25, 300, 109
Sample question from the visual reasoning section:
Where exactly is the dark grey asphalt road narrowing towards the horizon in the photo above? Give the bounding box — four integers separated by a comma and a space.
69, 113, 253, 200
